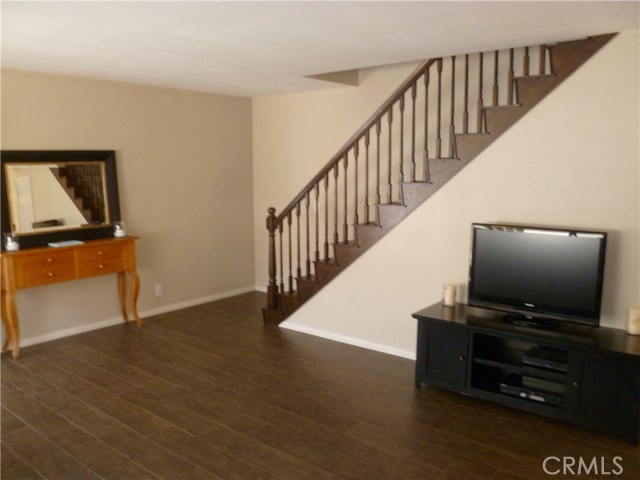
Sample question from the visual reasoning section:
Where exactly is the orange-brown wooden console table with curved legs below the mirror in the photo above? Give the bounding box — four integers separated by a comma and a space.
0, 237, 142, 358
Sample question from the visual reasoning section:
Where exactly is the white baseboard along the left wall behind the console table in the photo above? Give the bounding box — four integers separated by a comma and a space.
15, 286, 255, 348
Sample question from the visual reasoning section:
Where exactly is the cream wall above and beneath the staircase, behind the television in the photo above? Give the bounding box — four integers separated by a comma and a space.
253, 32, 640, 357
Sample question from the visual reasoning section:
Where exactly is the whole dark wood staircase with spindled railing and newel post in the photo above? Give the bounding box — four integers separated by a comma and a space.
263, 34, 615, 324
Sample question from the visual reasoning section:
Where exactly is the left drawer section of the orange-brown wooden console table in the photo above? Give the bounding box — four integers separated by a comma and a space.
16, 252, 75, 288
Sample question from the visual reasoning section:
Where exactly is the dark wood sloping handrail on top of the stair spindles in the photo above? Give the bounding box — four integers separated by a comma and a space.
269, 58, 439, 227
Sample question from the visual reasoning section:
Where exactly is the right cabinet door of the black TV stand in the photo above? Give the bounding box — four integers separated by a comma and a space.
566, 352, 640, 444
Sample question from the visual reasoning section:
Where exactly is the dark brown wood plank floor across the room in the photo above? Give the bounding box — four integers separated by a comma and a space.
2, 293, 640, 480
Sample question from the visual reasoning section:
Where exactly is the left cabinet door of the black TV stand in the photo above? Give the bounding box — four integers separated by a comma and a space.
416, 321, 469, 390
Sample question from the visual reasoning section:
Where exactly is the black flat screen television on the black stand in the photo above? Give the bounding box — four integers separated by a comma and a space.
468, 223, 607, 327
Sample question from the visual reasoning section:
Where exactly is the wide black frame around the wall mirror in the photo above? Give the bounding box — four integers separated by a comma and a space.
0, 150, 121, 250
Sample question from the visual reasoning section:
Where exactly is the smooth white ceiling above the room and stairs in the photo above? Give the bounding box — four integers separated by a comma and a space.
1, 0, 640, 96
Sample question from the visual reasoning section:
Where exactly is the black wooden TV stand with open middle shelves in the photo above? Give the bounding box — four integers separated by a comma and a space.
413, 303, 640, 445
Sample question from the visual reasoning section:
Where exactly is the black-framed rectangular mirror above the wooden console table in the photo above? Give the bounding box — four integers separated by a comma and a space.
0, 150, 120, 249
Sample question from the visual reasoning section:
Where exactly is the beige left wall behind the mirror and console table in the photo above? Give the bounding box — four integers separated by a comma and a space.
2, 70, 254, 344
